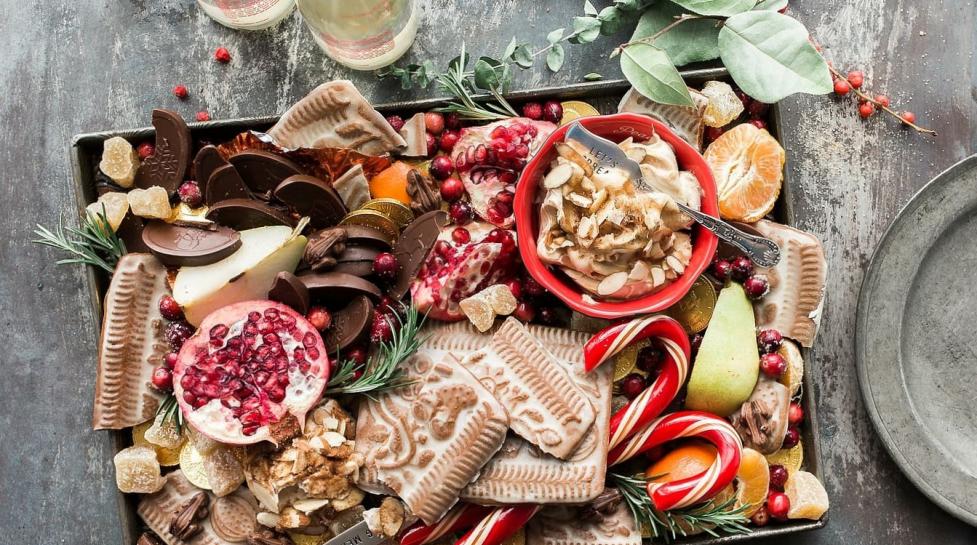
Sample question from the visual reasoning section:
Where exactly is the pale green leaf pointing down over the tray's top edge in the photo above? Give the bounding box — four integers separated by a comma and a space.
621, 43, 694, 106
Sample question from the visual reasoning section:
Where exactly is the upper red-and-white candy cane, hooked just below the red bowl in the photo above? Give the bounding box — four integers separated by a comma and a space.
584, 316, 692, 449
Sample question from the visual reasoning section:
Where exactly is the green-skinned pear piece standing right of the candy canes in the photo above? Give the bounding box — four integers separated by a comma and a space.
685, 283, 760, 416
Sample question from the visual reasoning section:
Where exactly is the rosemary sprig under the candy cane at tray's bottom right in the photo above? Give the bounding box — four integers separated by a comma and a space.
610, 473, 750, 543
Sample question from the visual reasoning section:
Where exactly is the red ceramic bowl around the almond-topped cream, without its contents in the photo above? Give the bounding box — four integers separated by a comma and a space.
515, 113, 719, 318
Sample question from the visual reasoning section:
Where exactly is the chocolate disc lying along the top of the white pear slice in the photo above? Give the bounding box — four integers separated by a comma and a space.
142, 221, 241, 267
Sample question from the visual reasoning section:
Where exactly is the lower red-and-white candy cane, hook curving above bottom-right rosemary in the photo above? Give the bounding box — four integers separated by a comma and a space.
607, 411, 743, 511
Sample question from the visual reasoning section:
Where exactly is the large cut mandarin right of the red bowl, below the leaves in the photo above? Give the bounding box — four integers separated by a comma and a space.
704, 123, 786, 223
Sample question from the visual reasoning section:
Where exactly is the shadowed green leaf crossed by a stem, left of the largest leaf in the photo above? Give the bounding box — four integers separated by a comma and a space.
631, 2, 719, 66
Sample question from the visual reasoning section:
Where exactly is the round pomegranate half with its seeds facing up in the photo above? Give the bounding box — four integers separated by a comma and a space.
173, 301, 329, 445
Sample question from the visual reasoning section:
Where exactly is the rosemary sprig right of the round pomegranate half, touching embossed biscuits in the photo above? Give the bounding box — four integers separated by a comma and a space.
328, 305, 424, 398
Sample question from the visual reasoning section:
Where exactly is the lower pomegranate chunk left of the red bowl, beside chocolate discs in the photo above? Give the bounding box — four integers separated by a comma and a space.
410, 222, 518, 322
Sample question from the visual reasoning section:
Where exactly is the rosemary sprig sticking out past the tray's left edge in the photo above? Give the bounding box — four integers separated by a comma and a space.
31, 204, 126, 274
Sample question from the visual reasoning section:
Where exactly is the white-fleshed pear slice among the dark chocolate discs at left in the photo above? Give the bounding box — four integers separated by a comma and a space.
173, 225, 308, 325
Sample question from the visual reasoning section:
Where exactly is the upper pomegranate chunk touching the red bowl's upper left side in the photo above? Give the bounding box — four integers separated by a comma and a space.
451, 117, 556, 229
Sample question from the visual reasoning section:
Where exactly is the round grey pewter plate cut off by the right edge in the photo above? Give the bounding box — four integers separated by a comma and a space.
856, 155, 977, 525
